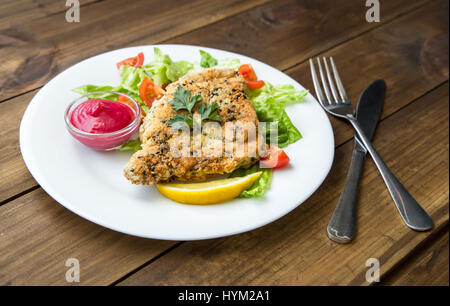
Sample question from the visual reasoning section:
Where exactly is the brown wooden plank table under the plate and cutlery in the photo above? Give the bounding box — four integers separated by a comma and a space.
0, 0, 449, 285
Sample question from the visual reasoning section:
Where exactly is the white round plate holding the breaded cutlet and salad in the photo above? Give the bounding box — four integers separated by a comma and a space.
20, 45, 334, 240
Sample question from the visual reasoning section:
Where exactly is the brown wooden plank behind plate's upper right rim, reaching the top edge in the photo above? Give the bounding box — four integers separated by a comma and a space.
166, 0, 428, 70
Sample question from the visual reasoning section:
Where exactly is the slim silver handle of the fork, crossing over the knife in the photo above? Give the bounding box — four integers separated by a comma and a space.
347, 115, 433, 231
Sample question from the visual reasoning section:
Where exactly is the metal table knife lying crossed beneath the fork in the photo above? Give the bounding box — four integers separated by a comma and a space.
327, 80, 386, 243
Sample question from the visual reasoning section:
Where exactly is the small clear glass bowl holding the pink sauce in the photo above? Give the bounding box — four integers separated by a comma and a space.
64, 91, 141, 151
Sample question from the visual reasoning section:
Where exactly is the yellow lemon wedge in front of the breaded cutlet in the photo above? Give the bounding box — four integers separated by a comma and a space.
156, 172, 262, 204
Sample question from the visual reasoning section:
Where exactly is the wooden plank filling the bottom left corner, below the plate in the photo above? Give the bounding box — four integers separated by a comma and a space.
0, 189, 174, 285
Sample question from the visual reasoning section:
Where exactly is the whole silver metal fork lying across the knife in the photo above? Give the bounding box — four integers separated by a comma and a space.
309, 57, 433, 231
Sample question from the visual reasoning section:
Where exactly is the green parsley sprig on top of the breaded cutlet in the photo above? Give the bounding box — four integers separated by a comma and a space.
167, 86, 222, 129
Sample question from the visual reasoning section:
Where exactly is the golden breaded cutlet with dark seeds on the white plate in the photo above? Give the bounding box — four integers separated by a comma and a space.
124, 68, 260, 185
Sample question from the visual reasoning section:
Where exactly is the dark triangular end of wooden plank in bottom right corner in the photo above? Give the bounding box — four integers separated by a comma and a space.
382, 226, 449, 286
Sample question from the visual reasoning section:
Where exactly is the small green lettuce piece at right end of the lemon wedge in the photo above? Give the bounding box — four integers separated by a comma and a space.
230, 164, 272, 198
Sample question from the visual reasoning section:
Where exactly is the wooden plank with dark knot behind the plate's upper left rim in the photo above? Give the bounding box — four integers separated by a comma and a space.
0, 0, 268, 101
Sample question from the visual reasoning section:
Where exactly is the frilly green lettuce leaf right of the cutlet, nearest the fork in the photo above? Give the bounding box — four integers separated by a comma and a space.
247, 82, 308, 148
